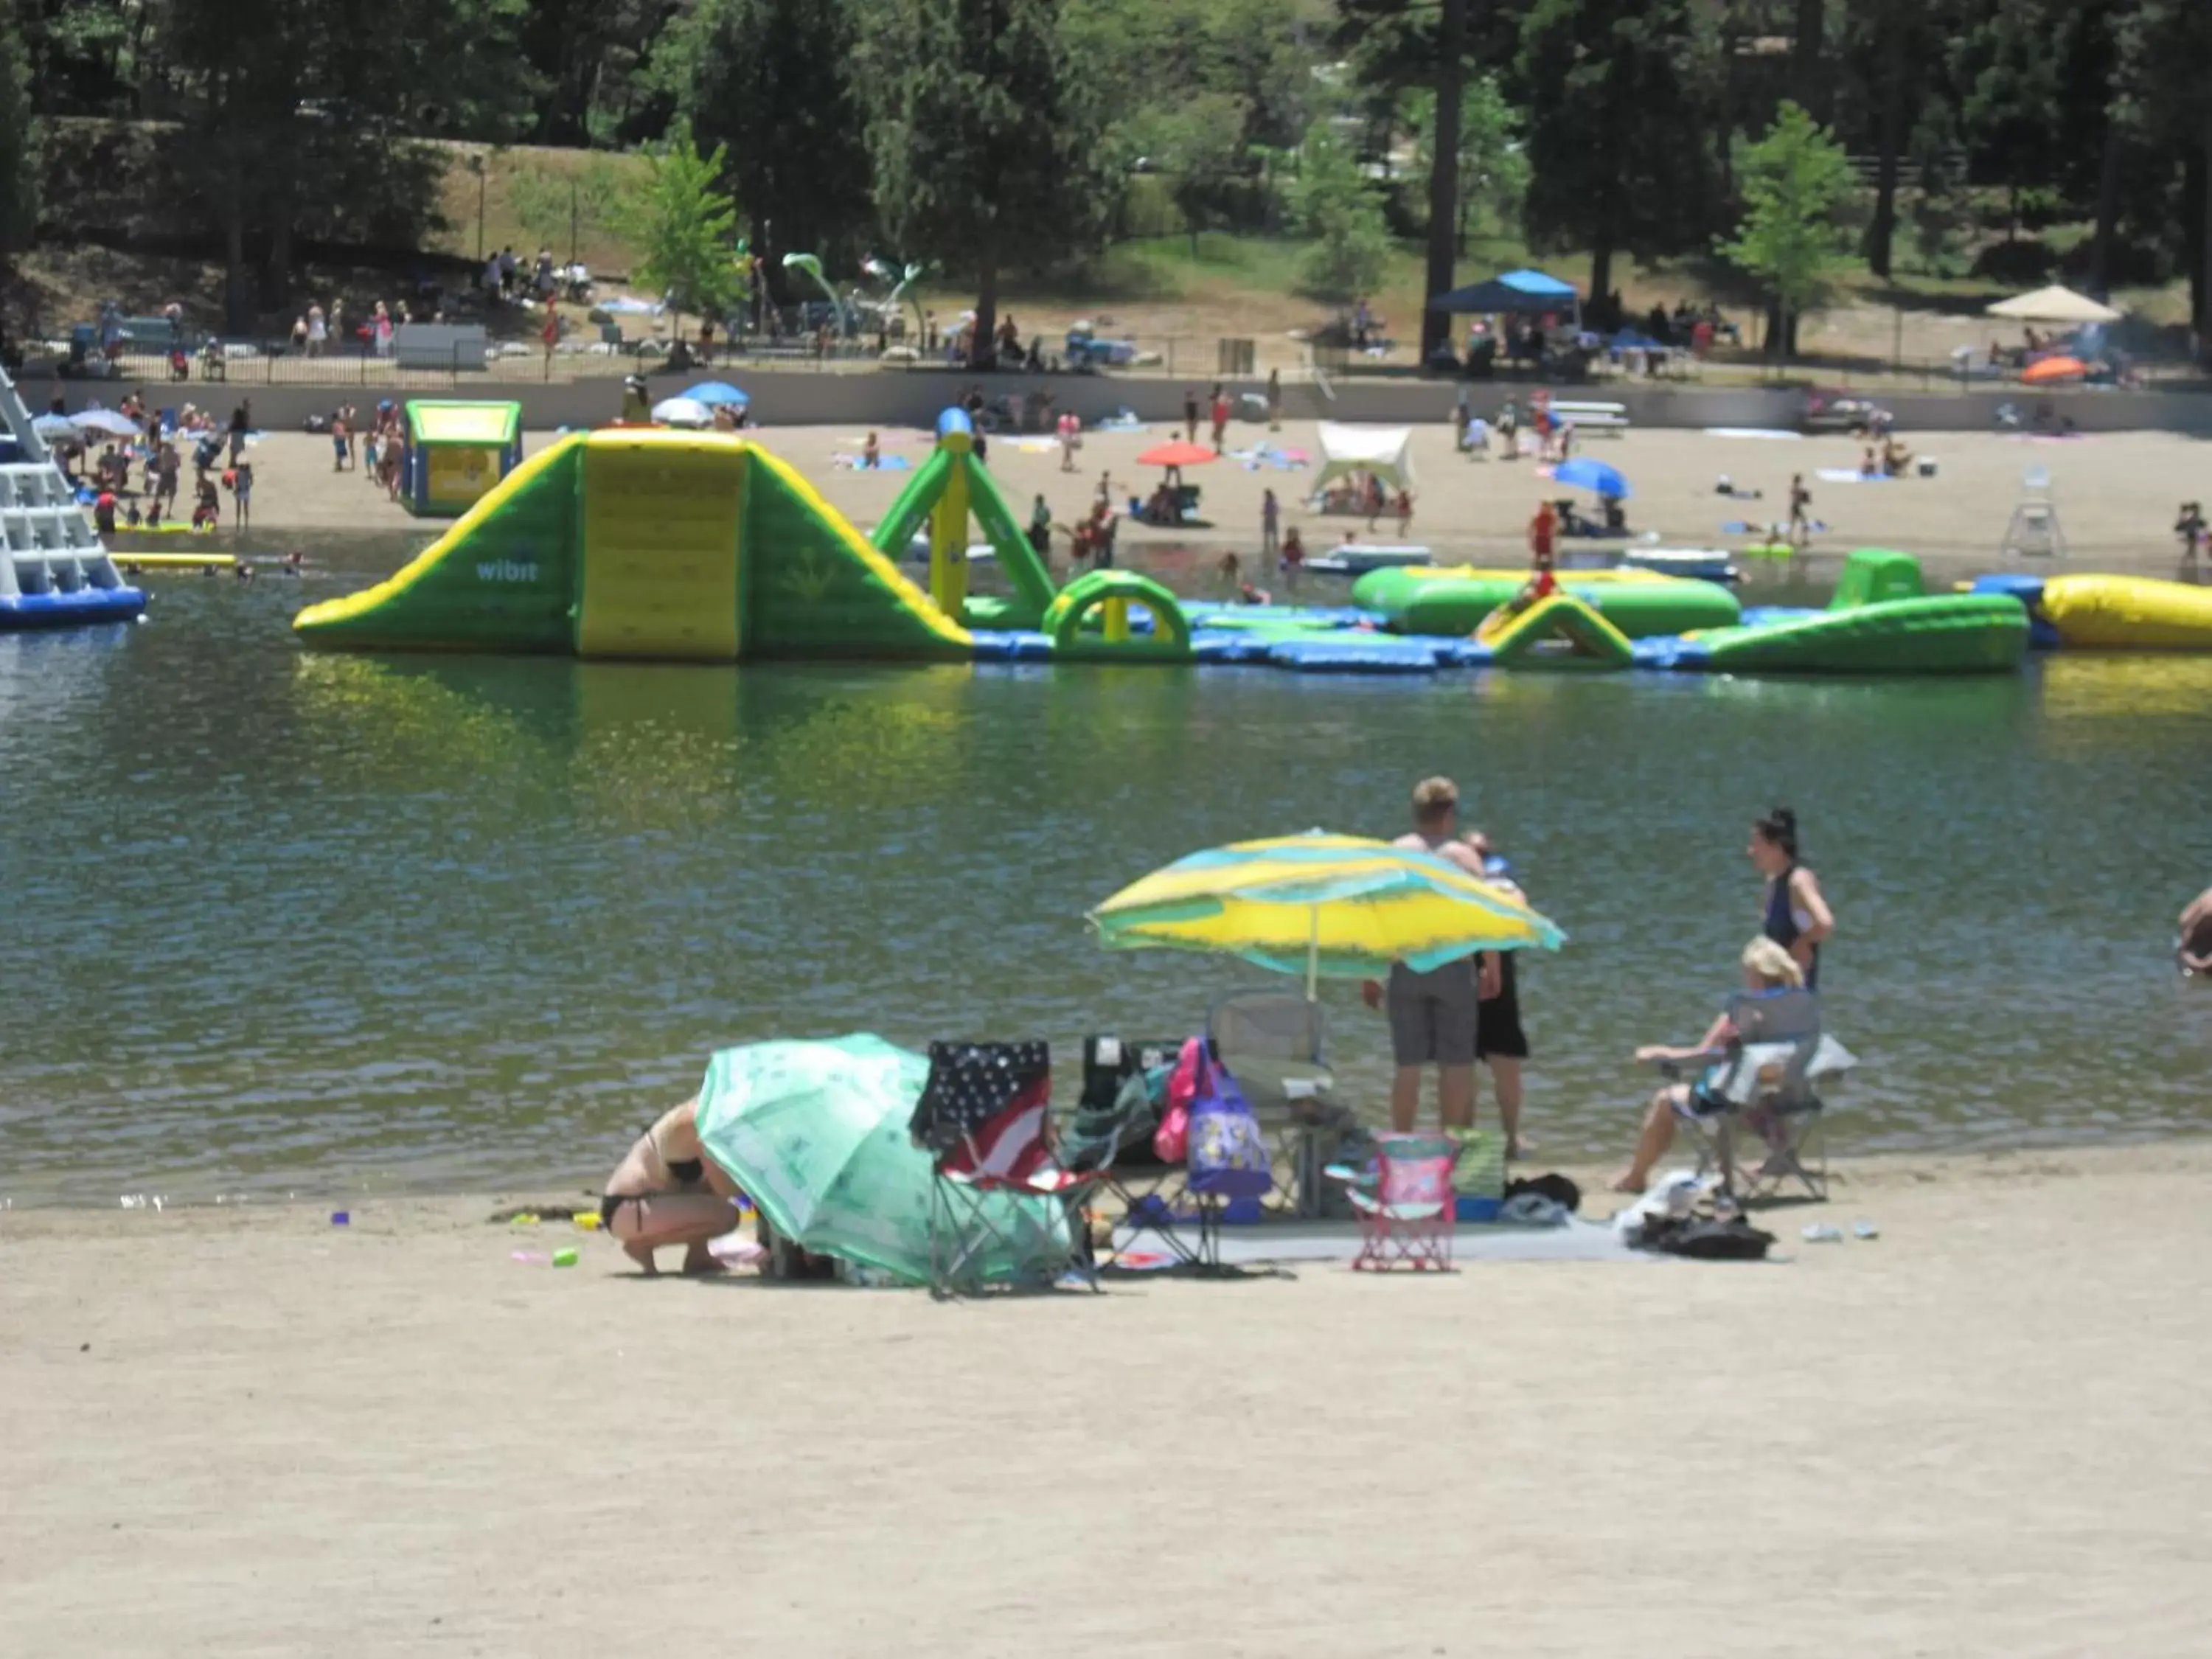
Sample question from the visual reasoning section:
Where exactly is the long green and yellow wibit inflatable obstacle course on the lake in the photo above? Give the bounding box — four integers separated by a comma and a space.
294, 409, 2028, 675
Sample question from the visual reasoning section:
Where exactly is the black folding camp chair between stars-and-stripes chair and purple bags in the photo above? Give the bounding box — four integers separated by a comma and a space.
1060, 1035, 1219, 1267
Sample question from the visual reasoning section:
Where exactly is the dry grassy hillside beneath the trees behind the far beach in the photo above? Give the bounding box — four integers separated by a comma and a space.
9, 122, 2185, 378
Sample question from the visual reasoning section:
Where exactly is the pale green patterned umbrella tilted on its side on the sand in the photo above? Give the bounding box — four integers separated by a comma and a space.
699, 1033, 1068, 1285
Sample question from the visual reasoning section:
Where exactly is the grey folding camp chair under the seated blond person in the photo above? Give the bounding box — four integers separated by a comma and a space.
1666, 989, 1856, 1199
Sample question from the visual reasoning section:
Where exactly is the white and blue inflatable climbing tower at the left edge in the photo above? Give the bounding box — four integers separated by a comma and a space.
0, 374, 146, 633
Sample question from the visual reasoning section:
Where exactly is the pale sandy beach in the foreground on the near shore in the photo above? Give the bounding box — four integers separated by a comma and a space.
0, 1126, 2212, 1659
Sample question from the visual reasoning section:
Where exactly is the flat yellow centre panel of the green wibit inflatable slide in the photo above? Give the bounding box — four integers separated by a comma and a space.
575, 427, 748, 661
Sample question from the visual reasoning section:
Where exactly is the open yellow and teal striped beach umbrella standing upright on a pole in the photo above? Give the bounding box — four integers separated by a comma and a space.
1088, 830, 1566, 995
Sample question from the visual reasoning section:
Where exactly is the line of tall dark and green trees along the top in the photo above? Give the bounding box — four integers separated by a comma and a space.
0, 0, 2212, 358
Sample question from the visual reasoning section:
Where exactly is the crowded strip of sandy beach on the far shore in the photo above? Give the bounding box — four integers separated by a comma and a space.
142, 420, 2212, 580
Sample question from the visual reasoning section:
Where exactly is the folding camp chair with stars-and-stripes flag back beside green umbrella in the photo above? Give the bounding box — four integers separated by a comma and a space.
907, 1042, 1097, 1298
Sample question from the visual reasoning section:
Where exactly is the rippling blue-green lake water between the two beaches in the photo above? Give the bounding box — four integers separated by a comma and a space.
0, 546, 2212, 1206
